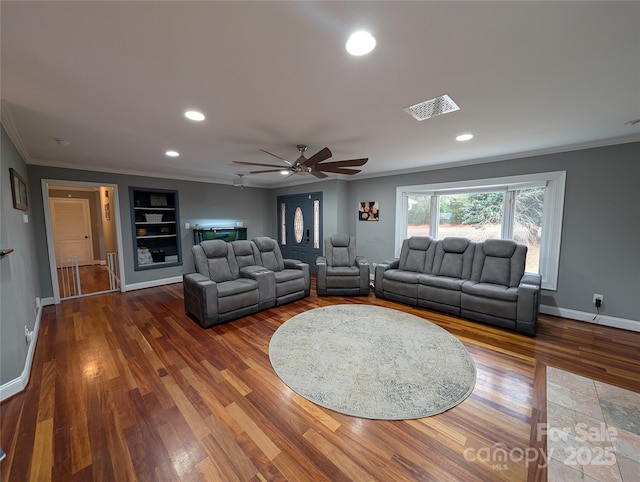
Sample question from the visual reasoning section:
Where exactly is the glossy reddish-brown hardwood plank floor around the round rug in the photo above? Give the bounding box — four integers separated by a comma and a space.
1, 284, 640, 482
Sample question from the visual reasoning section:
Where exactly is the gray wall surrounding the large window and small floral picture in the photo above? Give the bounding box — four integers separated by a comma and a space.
349, 142, 640, 321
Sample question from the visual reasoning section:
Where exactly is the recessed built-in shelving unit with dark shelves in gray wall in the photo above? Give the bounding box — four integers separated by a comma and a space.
129, 187, 182, 271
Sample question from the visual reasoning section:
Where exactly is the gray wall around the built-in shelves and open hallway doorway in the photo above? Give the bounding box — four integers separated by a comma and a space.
29, 165, 275, 297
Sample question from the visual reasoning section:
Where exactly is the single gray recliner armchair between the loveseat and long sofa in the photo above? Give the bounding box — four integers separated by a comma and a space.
316, 234, 369, 296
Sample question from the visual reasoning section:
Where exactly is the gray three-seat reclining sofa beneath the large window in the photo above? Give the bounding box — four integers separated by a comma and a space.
375, 236, 542, 335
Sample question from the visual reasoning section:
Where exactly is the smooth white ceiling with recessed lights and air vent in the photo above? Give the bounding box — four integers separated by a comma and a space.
1, 0, 640, 186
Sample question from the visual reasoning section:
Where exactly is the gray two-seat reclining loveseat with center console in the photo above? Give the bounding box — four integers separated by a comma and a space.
183, 237, 311, 328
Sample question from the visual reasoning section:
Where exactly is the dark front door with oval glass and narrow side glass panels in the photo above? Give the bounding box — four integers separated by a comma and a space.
278, 192, 322, 273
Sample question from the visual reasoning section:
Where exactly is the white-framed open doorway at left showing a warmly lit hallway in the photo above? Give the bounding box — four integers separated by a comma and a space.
42, 180, 123, 304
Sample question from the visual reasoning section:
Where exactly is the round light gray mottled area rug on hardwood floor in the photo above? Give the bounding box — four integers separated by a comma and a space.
269, 305, 476, 420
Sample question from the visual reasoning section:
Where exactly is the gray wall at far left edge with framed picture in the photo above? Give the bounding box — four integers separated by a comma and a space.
0, 128, 40, 385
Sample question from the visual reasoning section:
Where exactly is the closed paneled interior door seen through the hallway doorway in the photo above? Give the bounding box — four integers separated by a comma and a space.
50, 198, 93, 266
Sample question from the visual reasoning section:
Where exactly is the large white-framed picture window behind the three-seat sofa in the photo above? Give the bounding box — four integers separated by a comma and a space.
396, 171, 566, 290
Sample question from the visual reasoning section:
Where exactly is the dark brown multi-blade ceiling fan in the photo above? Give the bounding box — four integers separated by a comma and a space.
233, 144, 369, 179
